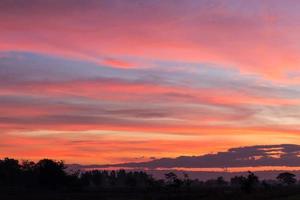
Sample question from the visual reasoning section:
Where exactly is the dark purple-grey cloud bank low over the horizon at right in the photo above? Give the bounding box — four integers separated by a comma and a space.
108, 144, 300, 168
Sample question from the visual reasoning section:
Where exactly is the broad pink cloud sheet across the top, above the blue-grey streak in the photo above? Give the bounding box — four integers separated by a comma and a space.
0, 1, 300, 81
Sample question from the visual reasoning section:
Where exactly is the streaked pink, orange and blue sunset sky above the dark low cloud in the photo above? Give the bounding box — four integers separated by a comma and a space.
0, 0, 300, 164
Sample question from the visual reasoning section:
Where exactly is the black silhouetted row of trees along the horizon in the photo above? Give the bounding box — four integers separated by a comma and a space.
0, 158, 298, 193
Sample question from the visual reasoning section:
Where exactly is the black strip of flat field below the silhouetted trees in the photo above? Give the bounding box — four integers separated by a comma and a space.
0, 189, 300, 200
